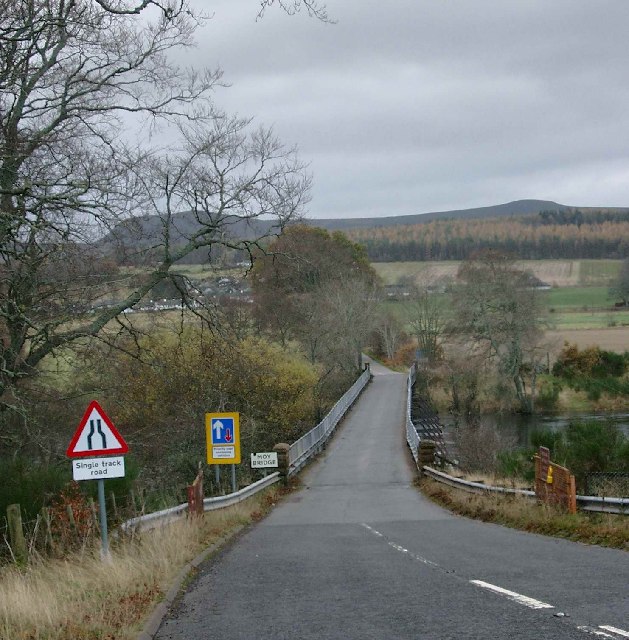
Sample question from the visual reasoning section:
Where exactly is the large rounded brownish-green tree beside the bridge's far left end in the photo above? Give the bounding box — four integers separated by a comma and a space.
252, 225, 377, 373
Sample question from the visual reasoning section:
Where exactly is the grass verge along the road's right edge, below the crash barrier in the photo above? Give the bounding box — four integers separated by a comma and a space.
419, 478, 629, 551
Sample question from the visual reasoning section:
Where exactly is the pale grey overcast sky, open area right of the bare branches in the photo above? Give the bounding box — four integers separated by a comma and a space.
180, 0, 629, 218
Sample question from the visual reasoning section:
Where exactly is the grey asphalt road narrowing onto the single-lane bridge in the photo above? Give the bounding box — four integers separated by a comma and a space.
157, 365, 629, 640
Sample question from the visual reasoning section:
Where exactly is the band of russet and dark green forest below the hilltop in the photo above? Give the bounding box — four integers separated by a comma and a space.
346, 210, 629, 262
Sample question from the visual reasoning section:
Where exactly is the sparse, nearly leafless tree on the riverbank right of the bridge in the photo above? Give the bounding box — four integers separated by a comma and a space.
452, 251, 542, 413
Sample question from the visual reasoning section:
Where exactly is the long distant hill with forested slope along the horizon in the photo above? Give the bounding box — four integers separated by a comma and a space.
99, 200, 629, 264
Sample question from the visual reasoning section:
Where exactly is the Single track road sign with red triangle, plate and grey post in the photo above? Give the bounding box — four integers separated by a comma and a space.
66, 400, 129, 560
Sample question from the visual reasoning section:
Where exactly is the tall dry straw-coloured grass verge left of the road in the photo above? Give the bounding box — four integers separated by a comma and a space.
0, 489, 278, 640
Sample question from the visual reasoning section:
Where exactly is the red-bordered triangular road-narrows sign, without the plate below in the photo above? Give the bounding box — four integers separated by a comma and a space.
66, 400, 129, 458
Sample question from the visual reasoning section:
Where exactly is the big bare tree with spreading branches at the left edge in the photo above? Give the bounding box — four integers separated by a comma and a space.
0, 0, 309, 406
